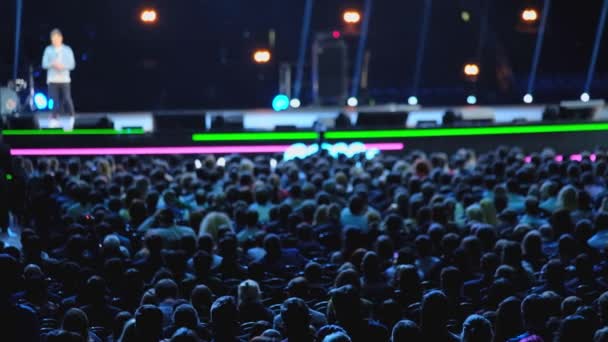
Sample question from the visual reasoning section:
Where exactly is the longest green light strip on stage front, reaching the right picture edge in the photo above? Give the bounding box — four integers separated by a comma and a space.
325, 123, 608, 140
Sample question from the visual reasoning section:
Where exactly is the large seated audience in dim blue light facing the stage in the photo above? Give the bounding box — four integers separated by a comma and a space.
0, 147, 608, 342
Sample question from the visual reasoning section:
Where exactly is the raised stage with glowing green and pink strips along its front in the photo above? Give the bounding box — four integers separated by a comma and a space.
3, 102, 608, 156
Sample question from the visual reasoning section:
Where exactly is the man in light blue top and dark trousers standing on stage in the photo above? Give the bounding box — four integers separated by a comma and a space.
42, 29, 76, 128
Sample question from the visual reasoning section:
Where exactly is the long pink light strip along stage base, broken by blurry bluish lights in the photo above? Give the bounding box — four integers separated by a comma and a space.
11, 143, 404, 156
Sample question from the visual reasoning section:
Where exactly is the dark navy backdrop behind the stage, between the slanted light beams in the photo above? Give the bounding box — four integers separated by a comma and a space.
0, 0, 608, 111
